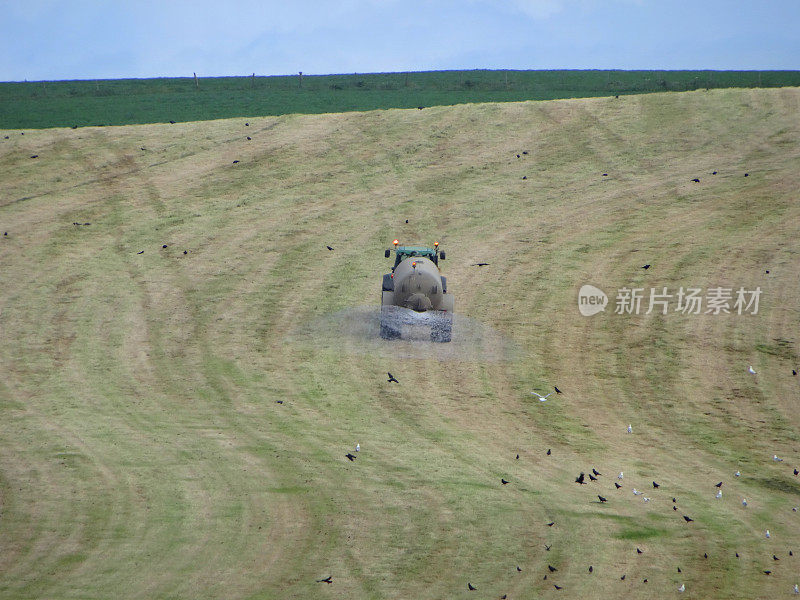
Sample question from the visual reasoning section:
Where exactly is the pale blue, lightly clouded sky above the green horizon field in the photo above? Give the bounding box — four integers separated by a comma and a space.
0, 0, 800, 81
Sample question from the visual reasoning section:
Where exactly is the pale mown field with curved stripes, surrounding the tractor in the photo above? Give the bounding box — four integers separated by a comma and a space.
0, 88, 800, 599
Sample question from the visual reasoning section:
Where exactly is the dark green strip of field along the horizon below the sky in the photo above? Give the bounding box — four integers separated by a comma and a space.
0, 70, 800, 129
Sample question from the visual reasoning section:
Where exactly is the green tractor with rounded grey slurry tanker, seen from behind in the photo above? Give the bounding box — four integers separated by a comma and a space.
381, 240, 453, 342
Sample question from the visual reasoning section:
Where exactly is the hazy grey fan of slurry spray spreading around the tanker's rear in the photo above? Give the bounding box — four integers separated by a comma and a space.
289, 306, 519, 362
